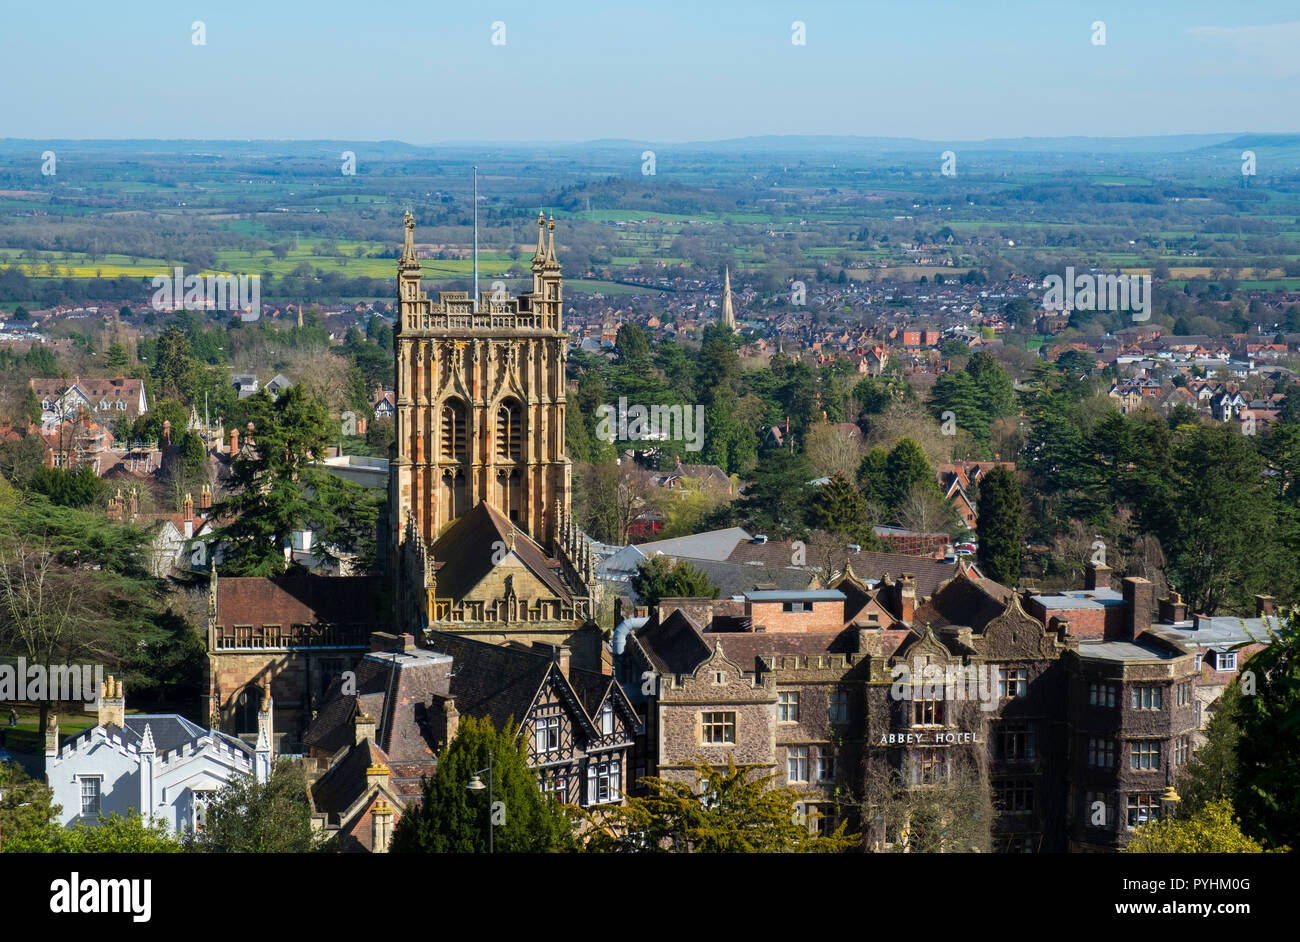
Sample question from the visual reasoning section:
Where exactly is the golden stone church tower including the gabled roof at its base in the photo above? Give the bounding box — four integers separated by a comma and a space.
389, 213, 601, 670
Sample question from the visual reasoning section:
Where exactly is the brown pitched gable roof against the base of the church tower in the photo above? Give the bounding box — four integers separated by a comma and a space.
429, 502, 572, 602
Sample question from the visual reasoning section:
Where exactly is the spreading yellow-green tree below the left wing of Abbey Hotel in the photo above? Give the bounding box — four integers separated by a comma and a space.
582, 755, 855, 854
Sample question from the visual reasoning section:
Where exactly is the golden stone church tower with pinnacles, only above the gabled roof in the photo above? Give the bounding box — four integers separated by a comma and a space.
389, 213, 572, 546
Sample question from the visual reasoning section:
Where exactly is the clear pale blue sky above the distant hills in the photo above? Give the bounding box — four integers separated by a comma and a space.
0, 0, 1300, 144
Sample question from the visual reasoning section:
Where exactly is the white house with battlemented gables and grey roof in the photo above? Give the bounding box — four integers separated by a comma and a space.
46, 677, 274, 833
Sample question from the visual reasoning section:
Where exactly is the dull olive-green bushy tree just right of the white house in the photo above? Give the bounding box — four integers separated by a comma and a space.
185, 759, 322, 854
